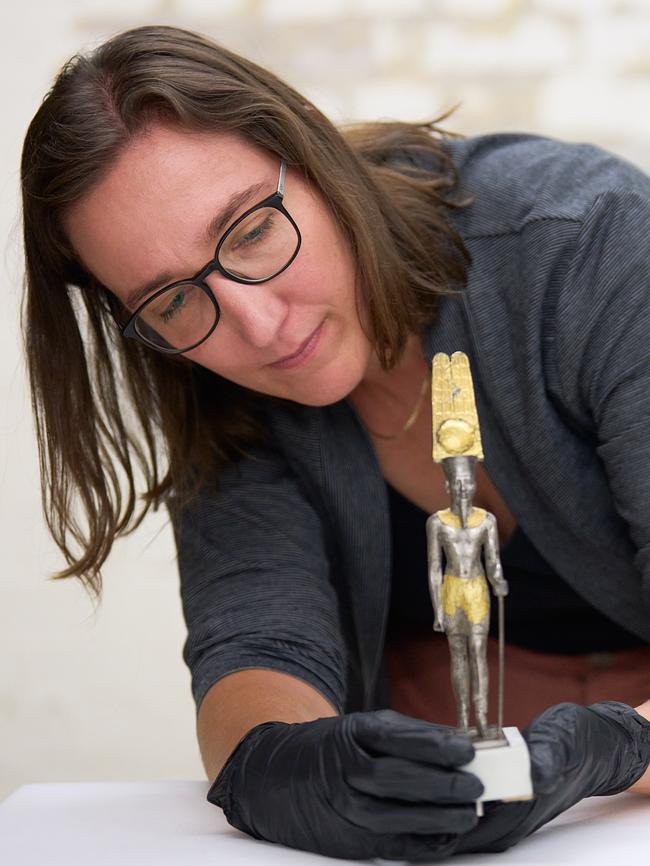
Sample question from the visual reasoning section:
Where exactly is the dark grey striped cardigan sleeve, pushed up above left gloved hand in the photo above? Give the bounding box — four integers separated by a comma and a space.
169, 438, 346, 713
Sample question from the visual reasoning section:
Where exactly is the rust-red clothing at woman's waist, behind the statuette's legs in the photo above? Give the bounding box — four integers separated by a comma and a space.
384, 631, 650, 728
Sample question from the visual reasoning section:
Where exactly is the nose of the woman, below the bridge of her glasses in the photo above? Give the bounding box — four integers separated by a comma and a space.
206, 272, 288, 349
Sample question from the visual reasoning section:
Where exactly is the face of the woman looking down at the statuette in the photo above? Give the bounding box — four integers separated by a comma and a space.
64, 125, 376, 406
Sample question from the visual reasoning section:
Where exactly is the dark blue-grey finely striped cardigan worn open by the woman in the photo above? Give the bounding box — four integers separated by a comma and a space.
170, 135, 650, 712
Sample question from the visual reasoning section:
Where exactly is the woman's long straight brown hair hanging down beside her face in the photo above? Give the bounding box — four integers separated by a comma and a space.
22, 27, 468, 598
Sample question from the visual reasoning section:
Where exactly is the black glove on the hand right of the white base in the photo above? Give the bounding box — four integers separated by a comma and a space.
456, 701, 650, 852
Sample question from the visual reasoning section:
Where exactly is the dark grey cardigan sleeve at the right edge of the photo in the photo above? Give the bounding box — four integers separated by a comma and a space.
555, 189, 650, 609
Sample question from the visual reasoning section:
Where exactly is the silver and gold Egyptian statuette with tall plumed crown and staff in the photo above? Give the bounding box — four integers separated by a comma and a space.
426, 352, 508, 740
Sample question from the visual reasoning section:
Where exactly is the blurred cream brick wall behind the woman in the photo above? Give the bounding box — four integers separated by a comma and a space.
0, 0, 650, 798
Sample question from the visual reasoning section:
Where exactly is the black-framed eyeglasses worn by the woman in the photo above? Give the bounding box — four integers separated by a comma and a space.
121, 160, 301, 355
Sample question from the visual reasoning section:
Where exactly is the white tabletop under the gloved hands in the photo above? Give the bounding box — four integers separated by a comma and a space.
0, 782, 650, 866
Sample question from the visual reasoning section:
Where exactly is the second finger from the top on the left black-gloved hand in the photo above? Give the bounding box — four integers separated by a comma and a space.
344, 757, 483, 803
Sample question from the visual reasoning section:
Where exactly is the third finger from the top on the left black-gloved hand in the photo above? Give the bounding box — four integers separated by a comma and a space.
332, 785, 478, 834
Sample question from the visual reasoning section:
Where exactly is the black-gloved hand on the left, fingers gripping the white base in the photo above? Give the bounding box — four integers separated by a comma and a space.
208, 710, 483, 861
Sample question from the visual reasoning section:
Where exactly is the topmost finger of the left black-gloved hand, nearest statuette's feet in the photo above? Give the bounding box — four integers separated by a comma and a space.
353, 710, 474, 767
